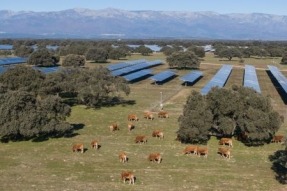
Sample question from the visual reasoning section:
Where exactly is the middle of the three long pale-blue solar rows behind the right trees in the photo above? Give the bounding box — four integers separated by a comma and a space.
243, 65, 261, 93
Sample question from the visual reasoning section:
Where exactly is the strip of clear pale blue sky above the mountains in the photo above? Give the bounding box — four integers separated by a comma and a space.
0, 0, 287, 15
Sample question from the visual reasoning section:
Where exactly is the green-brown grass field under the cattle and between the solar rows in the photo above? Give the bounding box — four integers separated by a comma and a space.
0, 54, 287, 191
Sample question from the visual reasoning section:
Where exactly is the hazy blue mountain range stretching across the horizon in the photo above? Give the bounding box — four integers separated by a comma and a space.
0, 8, 287, 40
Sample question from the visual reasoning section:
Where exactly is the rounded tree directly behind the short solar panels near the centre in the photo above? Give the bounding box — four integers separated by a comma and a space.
166, 51, 200, 69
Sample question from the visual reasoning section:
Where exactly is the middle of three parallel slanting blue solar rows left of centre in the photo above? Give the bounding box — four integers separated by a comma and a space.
111, 60, 162, 76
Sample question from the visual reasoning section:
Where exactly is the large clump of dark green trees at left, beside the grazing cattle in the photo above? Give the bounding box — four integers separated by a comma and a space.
0, 66, 130, 141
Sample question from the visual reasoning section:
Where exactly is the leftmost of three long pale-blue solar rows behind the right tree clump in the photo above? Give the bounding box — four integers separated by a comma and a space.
201, 64, 232, 95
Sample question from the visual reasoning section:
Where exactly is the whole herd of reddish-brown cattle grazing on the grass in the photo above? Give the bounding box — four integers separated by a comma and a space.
72, 111, 284, 184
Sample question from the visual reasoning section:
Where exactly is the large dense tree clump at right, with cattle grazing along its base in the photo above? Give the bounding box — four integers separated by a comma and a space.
177, 87, 282, 146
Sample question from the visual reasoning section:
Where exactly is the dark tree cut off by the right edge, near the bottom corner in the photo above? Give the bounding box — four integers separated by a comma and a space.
269, 149, 287, 184
